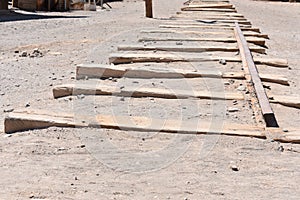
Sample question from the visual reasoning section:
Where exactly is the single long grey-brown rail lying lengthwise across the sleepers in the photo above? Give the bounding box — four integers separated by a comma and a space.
234, 23, 279, 127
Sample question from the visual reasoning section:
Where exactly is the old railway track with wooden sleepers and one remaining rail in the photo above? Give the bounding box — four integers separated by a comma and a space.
5, 0, 300, 142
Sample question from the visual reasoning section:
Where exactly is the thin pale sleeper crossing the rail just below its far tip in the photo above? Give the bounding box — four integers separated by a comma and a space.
159, 24, 260, 33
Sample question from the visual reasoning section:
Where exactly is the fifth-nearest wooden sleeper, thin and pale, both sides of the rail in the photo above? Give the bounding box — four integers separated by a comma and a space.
118, 45, 266, 54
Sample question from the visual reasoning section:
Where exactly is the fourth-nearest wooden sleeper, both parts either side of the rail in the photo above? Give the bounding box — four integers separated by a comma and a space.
109, 53, 288, 67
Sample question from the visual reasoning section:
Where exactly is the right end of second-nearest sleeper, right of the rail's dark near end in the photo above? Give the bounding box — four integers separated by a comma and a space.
269, 95, 300, 108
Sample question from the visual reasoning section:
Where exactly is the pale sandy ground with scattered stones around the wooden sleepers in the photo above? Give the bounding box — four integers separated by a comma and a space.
0, 0, 300, 199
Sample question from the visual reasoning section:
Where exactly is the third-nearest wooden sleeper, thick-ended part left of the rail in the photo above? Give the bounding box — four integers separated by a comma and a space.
76, 64, 245, 79
